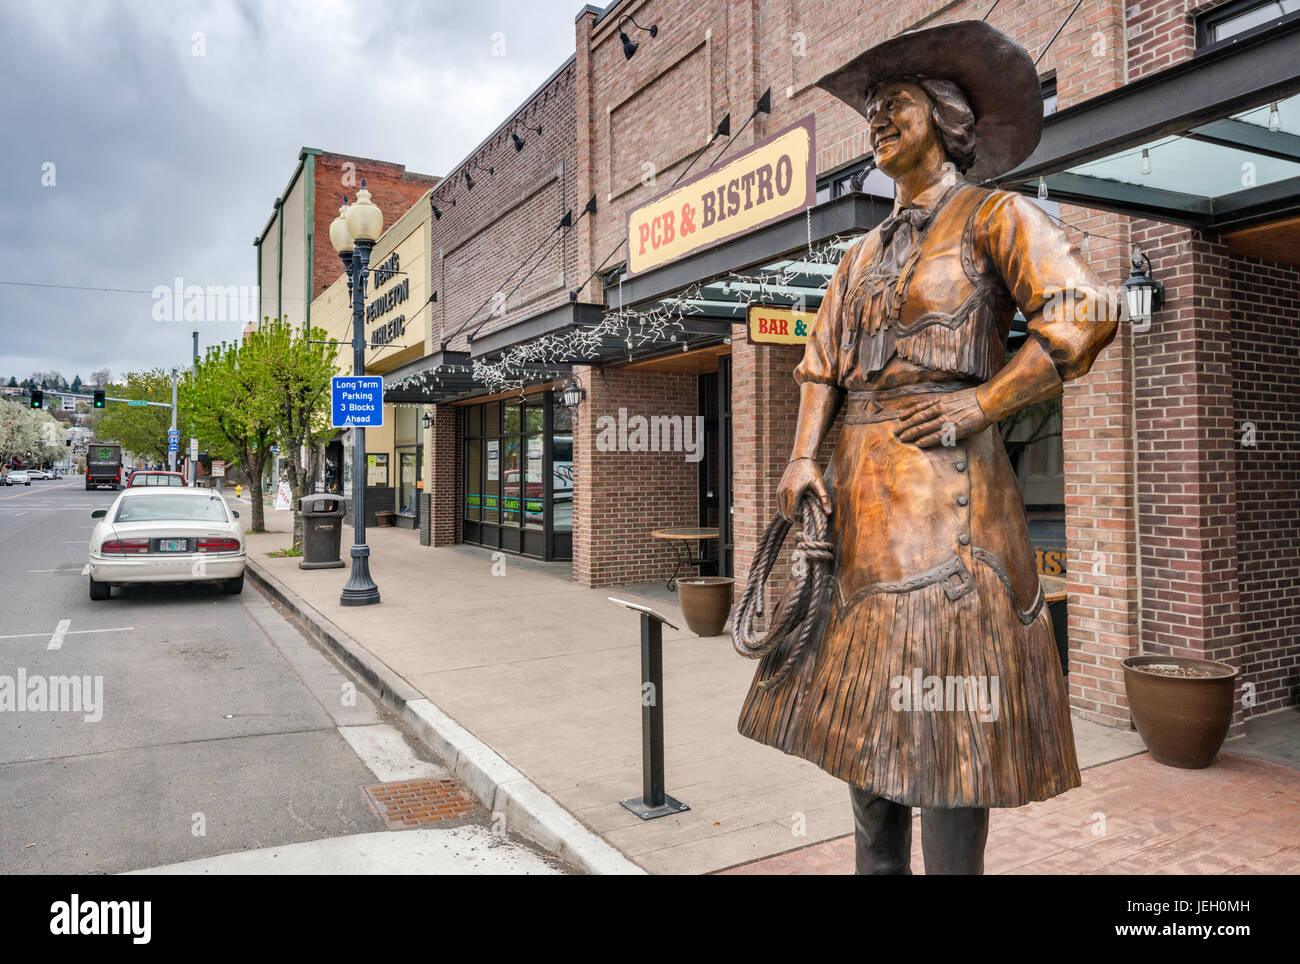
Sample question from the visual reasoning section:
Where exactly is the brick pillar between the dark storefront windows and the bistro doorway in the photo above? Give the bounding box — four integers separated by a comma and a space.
573, 369, 699, 586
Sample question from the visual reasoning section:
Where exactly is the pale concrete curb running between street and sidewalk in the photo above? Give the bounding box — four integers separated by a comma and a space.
244, 559, 646, 874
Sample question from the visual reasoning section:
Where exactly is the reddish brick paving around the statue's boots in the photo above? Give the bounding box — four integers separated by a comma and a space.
722, 752, 1300, 874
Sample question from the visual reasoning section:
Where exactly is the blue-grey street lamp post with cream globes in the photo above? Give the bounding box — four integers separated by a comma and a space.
329, 181, 384, 605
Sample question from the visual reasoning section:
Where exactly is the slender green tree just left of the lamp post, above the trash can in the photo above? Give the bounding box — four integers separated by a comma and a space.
260, 318, 335, 548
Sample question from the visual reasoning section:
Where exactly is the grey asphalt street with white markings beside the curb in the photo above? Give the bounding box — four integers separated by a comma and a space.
0, 479, 569, 873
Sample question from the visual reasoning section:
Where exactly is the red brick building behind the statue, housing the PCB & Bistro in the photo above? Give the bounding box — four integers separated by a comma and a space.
381, 0, 1300, 725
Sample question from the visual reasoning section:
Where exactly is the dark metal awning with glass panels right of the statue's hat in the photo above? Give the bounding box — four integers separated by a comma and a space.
998, 19, 1300, 233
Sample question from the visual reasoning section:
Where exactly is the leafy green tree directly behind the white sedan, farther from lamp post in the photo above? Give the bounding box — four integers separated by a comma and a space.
181, 330, 278, 533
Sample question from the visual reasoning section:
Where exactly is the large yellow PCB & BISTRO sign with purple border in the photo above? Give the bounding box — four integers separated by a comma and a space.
628, 117, 816, 274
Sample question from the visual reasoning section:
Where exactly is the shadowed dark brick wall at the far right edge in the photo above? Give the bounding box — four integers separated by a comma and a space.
1227, 256, 1300, 717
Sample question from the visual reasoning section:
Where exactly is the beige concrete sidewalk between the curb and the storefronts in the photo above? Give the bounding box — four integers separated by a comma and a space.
233, 512, 1170, 873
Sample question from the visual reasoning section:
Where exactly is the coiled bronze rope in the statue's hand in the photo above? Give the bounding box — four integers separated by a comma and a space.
732, 492, 835, 690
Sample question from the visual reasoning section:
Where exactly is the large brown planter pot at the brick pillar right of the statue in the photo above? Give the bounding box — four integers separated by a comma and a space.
1122, 656, 1242, 770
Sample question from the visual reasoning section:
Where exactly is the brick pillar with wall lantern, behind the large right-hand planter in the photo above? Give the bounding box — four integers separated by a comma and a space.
1134, 221, 1240, 660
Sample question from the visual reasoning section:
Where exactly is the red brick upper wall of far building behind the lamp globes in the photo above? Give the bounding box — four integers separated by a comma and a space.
312, 153, 441, 298
